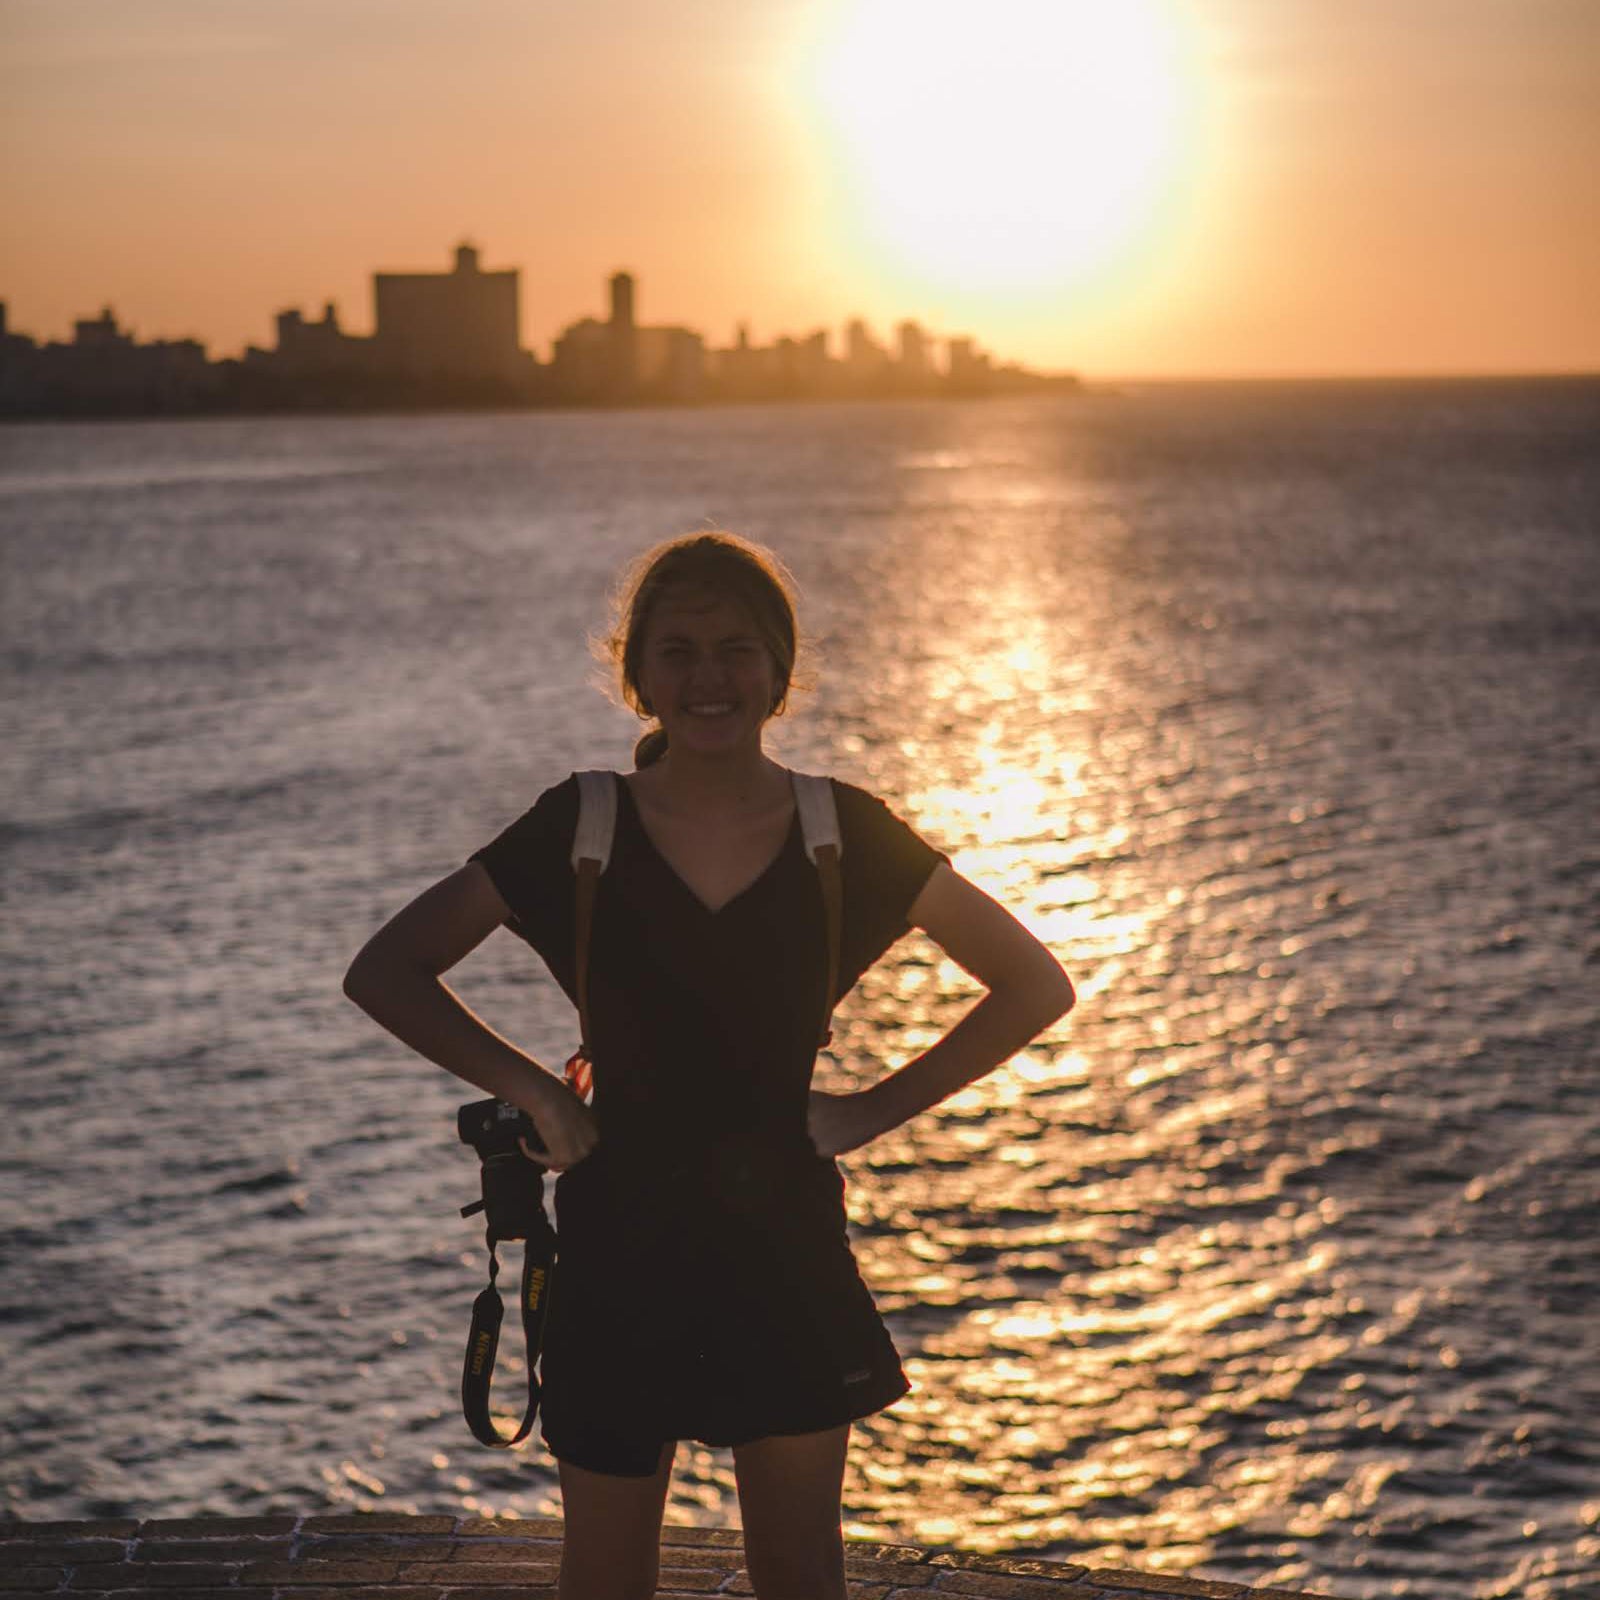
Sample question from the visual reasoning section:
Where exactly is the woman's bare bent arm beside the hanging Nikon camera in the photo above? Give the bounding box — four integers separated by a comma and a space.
344, 861, 598, 1171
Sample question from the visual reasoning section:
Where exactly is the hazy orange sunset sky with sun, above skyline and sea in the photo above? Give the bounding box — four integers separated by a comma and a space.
0, 0, 1600, 376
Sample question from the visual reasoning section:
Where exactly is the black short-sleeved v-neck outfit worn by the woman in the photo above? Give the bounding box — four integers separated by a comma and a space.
472, 778, 946, 1475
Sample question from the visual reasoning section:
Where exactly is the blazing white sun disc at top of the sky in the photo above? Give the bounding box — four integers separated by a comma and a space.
814, 0, 1192, 293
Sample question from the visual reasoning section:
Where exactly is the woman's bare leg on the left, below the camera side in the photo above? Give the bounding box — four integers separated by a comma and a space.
557, 1443, 677, 1600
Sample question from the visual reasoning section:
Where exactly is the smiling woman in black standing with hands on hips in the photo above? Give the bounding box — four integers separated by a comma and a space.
346, 533, 1074, 1600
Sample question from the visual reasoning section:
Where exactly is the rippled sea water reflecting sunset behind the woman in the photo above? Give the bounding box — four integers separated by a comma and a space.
0, 384, 1600, 1600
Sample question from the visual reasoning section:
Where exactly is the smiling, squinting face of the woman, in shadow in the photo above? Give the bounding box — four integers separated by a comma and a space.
638, 584, 781, 755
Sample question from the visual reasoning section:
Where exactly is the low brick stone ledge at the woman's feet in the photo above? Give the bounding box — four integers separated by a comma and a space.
0, 1512, 1344, 1600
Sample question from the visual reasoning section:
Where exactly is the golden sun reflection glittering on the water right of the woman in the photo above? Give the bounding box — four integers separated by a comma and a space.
790, 450, 1427, 1581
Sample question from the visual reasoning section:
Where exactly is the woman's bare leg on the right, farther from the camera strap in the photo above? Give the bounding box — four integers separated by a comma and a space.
733, 1422, 850, 1600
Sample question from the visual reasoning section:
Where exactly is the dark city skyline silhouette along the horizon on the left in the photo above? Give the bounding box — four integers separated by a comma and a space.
0, 240, 1078, 418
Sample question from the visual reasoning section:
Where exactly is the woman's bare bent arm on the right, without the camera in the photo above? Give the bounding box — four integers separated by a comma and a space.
810, 862, 1077, 1155
